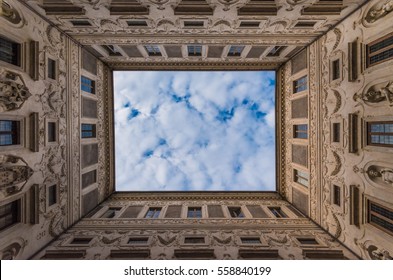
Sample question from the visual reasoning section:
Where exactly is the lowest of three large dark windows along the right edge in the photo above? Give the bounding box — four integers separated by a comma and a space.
368, 201, 393, 234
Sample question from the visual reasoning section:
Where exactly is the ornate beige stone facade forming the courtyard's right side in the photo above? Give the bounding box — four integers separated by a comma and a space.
280, 1, 393, 259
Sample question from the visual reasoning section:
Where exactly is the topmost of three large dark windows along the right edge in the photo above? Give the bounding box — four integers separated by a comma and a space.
366, 33, 393, 67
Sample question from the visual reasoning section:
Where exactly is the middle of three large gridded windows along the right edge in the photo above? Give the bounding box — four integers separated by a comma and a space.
367, 121, 393, 147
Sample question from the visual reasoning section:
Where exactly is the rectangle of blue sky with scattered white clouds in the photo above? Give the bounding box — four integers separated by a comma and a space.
114, 71, 276, 191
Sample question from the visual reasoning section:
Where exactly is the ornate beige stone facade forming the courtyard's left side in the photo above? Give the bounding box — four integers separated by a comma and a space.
0, 1, 110, 259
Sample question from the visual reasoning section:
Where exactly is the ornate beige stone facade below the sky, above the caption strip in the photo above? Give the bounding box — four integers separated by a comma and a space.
35, 193, 356, 259
